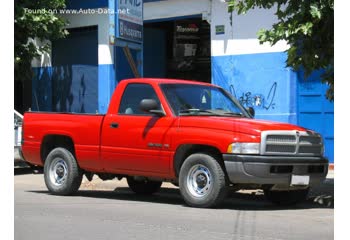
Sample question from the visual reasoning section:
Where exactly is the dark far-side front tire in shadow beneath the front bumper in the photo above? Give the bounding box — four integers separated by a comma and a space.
264, 188, 309, 206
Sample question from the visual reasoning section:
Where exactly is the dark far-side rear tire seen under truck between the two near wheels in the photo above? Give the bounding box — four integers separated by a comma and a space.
126, 177, 162, 195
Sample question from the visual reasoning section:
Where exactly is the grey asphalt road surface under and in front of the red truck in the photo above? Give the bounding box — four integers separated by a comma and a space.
14, 170, 334, 240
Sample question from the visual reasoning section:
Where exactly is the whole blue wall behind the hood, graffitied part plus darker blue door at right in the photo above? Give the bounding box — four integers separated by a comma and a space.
212, 53, 334, 163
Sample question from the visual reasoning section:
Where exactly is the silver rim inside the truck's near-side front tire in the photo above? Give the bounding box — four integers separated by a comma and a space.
187, 164, 212, 198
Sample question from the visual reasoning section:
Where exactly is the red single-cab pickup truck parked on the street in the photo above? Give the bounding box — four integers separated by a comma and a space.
22, 78, 328, 207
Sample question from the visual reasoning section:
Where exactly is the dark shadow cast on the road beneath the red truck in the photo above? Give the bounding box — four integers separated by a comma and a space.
28, 179, 334, 211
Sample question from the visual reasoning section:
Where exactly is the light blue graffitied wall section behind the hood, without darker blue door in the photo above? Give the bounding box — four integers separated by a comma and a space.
212, 53, 297, 123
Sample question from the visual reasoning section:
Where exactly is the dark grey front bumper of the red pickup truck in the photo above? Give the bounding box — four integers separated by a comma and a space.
223, 154, 328, 186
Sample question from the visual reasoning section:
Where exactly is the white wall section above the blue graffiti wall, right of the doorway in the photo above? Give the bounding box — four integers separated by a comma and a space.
211, 0, 287, 56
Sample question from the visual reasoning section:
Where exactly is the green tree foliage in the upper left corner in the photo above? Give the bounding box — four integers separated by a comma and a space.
14, 0, 68, 81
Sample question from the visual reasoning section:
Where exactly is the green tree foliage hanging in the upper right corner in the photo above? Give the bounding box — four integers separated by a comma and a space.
228, 0, 334, 101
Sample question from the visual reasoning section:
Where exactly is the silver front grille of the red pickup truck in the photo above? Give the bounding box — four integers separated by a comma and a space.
261, 131, 323, 156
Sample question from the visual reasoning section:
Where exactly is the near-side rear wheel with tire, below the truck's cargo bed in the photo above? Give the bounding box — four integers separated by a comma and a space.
44, 148, 83, 195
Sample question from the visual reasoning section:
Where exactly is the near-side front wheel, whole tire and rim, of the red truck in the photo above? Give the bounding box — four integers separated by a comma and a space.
179, 153, 227, 208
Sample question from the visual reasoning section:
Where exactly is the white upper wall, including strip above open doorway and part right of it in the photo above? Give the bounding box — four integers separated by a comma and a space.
144, 0, 288, 56
